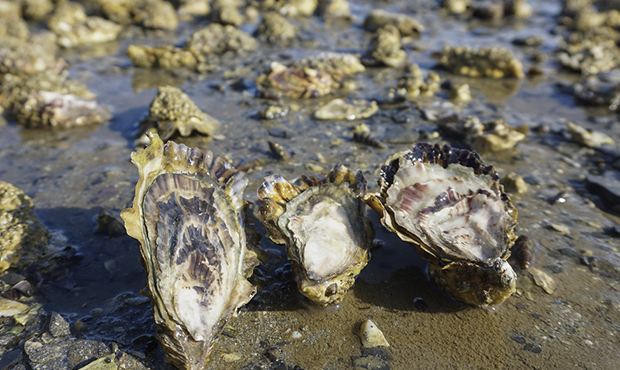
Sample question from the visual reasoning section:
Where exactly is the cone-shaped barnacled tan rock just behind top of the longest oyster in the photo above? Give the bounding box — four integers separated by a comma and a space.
138, 86, 221, 142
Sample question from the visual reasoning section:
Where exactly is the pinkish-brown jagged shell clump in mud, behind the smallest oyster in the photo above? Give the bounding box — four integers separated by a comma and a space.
256, 53, 365, 98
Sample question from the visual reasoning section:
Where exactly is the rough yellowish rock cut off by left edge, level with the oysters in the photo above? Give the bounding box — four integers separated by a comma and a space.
0, 181, 48, 273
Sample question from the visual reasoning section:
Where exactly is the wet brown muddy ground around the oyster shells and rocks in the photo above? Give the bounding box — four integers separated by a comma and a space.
0, 1, 620, 369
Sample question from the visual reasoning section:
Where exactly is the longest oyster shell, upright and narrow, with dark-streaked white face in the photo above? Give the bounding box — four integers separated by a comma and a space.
121, 130, 258, 369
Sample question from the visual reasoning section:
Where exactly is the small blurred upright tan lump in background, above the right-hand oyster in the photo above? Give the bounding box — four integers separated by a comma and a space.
362, 24, 407, 67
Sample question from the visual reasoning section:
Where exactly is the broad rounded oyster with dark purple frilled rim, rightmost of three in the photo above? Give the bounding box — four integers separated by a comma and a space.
365, 143, 517, 305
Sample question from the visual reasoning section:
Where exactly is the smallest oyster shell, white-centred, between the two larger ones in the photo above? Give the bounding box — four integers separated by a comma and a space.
258, 166, 372, 306
